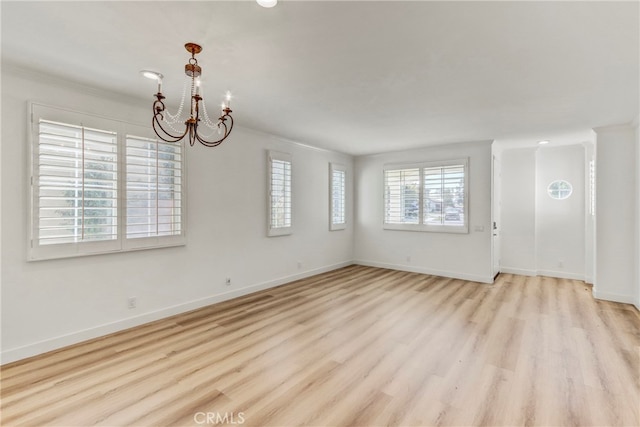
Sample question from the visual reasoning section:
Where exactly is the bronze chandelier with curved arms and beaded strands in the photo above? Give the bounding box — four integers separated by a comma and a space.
141, 43, 233, 147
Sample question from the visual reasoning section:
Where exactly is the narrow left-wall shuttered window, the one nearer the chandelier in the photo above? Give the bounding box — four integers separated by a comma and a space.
267, 151, 292, 236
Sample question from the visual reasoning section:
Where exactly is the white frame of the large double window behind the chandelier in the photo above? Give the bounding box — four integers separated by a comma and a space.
27, 101, 187, 261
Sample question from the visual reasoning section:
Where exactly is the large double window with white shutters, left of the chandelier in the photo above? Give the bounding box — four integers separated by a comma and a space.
29, 104, 184, 260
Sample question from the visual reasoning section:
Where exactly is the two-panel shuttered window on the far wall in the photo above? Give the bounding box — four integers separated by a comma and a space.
384, 159, 469, 233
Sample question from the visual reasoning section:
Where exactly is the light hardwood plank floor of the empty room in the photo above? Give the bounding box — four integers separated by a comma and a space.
1, 266, 640, 426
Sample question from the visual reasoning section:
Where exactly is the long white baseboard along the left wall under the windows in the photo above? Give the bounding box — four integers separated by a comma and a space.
0, 261, 353, 364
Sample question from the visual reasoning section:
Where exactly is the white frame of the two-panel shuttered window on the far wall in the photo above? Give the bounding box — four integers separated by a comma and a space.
382, 157, 469, 234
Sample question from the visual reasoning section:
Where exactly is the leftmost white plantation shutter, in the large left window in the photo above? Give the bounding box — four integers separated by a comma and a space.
34, 119, 118, 246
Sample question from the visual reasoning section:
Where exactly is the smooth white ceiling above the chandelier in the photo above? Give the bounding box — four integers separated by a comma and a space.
1, 0, 640, 155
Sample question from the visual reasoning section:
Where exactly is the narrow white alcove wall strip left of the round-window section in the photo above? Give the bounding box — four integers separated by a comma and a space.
498, 148, 536, 276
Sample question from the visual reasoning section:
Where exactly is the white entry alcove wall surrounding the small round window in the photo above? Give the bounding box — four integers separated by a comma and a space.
501, 144, 592, 280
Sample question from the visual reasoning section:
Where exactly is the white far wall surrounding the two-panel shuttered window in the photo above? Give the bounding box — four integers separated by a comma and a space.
354, 141, 493, 283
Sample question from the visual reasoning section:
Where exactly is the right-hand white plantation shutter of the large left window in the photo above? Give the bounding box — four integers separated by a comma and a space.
126, 135, 183, 239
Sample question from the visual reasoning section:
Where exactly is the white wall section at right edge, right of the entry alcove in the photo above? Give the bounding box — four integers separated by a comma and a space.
593, 126, 638, 303
